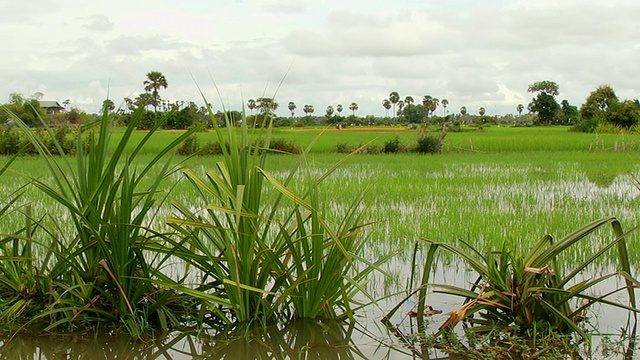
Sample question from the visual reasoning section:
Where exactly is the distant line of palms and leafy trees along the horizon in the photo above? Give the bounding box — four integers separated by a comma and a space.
0, 71, 640, 132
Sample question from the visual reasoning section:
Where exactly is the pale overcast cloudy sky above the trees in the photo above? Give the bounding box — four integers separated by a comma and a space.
0, 0, 640, 116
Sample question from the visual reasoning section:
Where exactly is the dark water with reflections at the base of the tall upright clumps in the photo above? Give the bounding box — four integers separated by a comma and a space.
0, 320, 371, 360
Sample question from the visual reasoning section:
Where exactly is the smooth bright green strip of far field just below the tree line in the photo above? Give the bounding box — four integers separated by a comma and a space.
106, 126, 640, 154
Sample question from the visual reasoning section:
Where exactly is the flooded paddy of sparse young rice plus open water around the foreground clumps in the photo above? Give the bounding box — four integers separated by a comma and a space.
5, 153, 640, 359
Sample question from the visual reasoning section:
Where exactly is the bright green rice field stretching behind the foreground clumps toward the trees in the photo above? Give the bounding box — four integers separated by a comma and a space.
0, 124, 640, 359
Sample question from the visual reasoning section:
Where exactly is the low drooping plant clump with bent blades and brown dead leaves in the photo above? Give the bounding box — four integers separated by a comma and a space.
386, 217, 638, 348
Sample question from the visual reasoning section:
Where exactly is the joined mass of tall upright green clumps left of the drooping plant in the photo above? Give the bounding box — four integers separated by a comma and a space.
0, 99, 387, 336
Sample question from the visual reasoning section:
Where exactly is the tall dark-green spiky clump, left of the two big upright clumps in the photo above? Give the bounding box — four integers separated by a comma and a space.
7, 109, 195, 329
